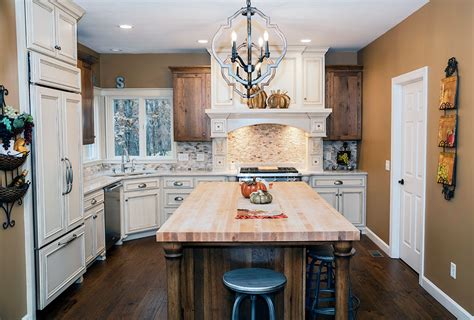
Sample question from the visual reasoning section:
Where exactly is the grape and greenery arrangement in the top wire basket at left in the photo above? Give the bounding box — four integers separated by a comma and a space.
0, 106, 34, 151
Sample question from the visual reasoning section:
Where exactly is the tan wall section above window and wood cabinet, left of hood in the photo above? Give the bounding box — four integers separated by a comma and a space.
100, 52, 211, 88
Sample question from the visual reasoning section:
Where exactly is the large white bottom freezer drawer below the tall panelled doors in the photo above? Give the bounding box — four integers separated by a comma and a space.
38, 226, 86, 310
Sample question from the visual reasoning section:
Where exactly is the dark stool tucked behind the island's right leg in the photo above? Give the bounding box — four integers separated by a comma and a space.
306, 245, 360, 319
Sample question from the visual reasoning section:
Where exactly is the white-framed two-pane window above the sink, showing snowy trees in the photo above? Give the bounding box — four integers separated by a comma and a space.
107, 89, 175, 160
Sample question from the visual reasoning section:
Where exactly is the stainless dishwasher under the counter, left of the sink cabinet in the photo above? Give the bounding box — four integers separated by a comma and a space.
104, 182, 122, 250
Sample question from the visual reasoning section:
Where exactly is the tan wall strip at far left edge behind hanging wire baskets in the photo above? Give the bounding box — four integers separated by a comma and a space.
0, 0, 26, 320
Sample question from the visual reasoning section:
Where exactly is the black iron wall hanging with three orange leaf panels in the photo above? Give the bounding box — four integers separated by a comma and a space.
436, 57, 459, 201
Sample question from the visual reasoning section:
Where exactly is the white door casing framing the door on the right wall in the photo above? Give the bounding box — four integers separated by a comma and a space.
389, 66, 428, 284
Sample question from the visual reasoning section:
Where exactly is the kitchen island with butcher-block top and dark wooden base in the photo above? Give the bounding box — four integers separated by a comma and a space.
156, 182, 360, 320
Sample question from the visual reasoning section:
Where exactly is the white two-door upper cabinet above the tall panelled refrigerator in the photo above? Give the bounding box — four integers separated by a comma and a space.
26, 0, 84, 65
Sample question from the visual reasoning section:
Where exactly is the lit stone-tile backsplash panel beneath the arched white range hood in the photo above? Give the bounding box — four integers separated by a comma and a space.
227, 124, 307, 168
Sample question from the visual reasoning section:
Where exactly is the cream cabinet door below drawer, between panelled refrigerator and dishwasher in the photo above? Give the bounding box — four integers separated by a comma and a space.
84, 203, 105, 264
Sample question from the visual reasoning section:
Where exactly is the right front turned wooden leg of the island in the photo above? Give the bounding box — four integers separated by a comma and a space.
334, 241, 352, 320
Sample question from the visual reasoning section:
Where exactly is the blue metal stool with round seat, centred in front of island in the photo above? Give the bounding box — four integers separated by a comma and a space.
223, 268, 286, 320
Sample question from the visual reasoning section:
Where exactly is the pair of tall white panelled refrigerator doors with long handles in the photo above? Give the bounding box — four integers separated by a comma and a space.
31, 86, 84, 247
